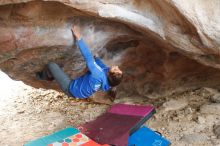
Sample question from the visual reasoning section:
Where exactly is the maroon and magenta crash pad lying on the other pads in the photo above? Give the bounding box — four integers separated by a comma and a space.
81, 104, 155, 146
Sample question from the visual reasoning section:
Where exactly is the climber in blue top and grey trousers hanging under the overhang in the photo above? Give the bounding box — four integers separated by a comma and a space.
36, 26, 123, 101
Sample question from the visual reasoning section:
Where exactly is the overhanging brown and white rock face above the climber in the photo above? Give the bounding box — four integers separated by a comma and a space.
0, 0, 220, 97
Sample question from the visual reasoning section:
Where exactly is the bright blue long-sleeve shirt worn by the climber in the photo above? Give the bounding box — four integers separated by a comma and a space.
69, 39, 110, 98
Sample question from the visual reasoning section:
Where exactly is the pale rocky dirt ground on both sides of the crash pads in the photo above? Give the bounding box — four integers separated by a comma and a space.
0, 70, 220, 146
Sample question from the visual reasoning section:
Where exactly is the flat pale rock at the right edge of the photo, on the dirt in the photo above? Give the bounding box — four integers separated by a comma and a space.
200, 103, 220, 115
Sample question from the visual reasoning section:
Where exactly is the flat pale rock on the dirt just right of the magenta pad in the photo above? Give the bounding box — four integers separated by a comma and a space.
163, 100, 188, 111
